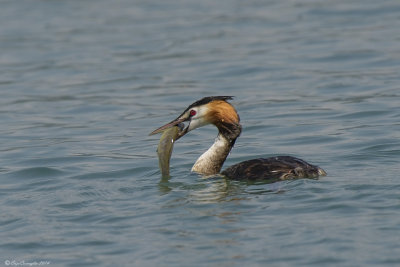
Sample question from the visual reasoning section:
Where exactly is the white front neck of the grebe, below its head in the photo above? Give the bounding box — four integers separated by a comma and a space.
192, 134, 232, 175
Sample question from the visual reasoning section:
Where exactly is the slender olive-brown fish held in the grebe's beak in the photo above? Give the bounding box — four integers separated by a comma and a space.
157, 123, 184, 178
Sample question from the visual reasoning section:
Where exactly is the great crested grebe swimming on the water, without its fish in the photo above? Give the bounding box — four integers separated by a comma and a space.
150, 96, 326, 180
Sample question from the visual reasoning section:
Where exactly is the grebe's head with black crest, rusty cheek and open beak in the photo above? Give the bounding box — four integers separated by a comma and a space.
150, 96, 241, 142
